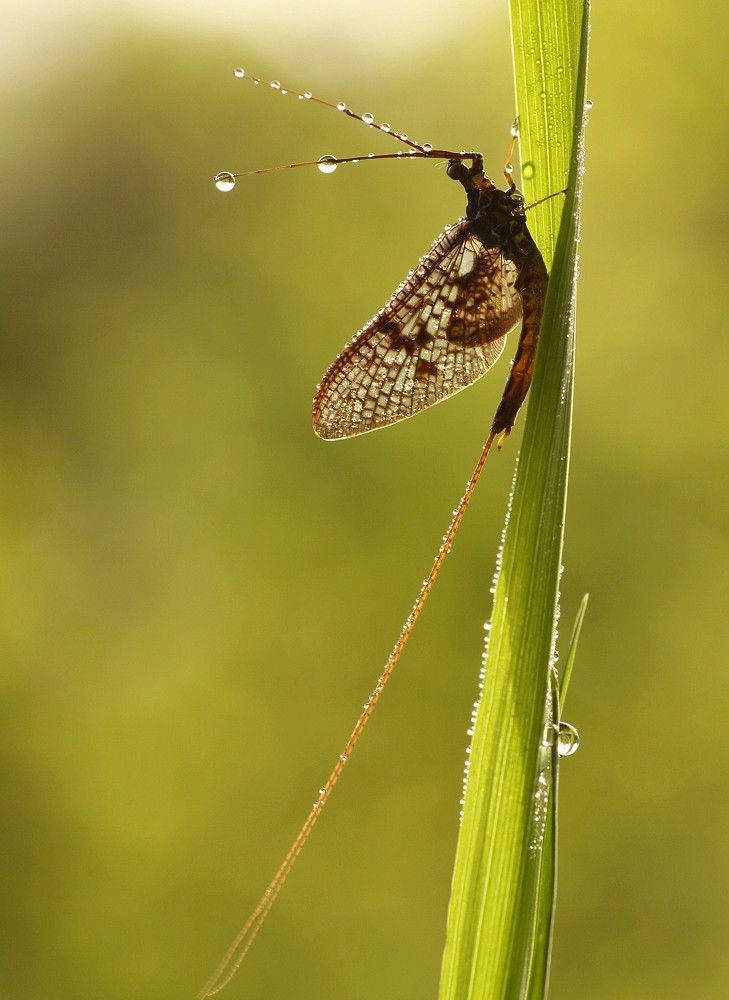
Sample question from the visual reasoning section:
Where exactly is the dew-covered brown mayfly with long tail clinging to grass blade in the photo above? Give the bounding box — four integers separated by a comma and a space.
199, 69, 548, 998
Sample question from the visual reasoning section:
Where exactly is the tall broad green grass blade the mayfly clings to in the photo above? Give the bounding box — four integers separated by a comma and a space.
440, 0, 589, 1000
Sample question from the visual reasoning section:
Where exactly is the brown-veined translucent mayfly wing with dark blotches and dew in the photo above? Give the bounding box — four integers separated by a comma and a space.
313, 219, 522, 439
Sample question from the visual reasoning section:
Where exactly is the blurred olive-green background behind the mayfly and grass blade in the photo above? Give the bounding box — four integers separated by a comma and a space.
0, 0, 729, 1000
